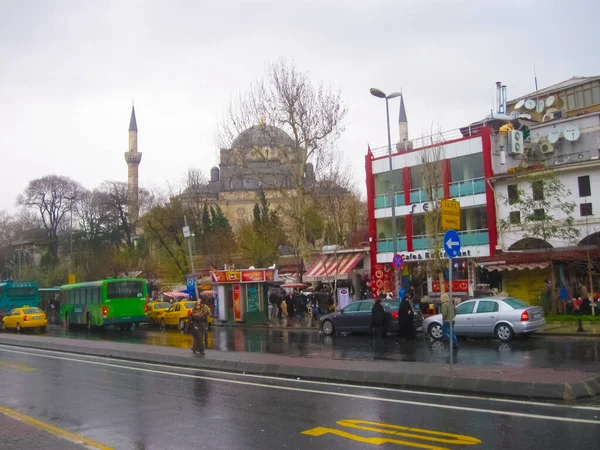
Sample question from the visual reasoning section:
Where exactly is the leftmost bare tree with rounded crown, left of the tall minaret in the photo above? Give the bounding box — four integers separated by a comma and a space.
17, 175, 83, 263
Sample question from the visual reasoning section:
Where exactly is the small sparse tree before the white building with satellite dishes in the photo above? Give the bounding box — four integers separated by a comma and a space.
501, 171, 580, 314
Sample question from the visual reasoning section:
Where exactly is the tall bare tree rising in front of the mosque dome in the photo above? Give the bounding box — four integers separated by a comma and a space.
219, 60, 347, 270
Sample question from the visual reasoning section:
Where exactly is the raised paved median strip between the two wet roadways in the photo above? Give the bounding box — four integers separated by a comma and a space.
0, 334, 600, 400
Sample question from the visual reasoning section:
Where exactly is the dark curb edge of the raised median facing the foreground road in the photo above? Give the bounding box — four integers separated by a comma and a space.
0, 339, 600, 401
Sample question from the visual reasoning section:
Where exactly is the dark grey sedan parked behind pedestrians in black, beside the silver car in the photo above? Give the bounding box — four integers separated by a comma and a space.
319, 299, 423, 336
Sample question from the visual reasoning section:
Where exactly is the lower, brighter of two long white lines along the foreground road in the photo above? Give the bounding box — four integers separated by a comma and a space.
0, 349, 600, 425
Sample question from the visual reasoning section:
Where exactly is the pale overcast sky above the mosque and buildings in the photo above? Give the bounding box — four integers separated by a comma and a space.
0, 0, 600, 211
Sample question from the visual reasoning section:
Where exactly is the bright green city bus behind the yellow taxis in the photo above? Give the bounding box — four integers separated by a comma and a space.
60, 278, 148, 329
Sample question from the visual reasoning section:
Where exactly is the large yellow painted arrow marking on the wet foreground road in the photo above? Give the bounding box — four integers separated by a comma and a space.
302, 419, 481, 450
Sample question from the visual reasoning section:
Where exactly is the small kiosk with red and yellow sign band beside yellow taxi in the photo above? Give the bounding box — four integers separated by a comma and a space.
211, 269, 276, 324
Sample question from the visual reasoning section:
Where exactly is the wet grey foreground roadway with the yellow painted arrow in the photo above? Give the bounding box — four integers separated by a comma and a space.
0, 346, 600, 450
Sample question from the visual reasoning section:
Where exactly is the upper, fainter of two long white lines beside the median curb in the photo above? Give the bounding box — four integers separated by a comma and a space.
0, 344, 600, 411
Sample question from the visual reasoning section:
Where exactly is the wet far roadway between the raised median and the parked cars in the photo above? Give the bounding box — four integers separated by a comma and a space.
34, 326, 600, 371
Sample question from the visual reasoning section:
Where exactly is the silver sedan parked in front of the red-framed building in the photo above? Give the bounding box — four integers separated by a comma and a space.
423, 297, 546, 342
